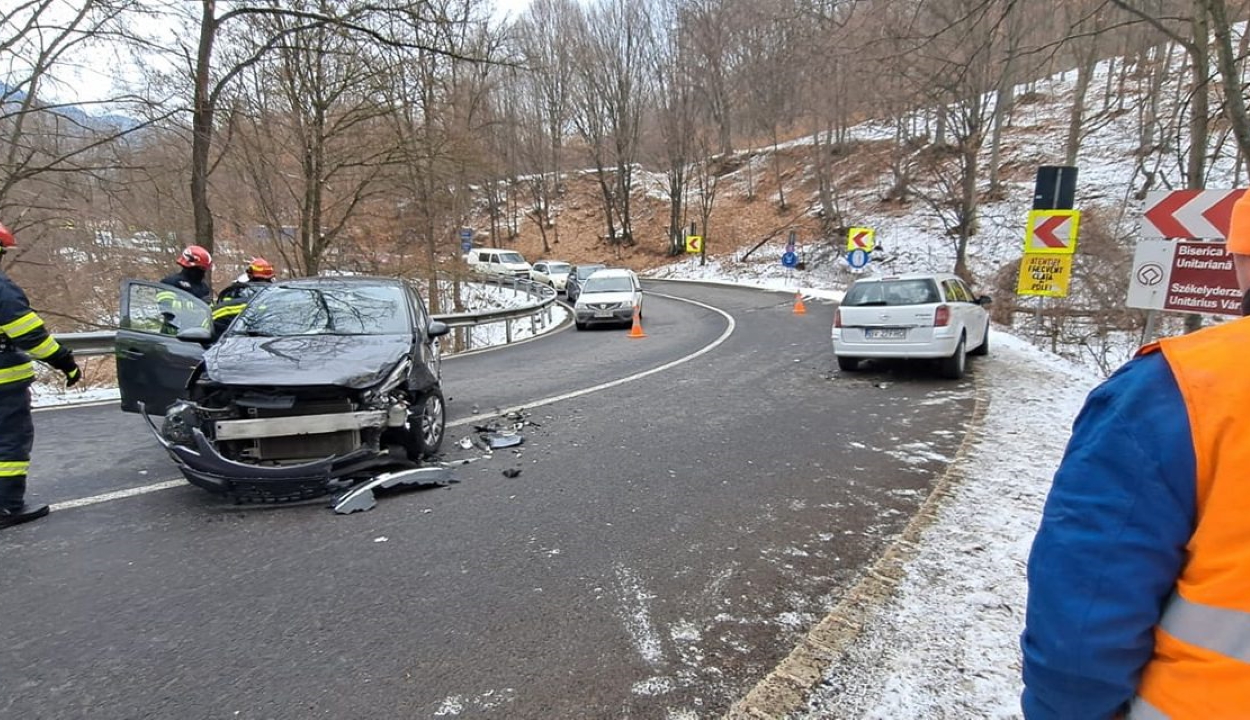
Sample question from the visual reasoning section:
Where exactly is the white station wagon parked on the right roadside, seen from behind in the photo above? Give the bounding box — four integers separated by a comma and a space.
833, 274, 990, 379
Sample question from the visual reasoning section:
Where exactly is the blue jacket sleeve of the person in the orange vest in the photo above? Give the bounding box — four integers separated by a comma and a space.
1021, 353, 1198, 720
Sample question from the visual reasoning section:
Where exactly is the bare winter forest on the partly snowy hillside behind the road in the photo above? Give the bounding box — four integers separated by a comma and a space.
0, 0, 1250, 368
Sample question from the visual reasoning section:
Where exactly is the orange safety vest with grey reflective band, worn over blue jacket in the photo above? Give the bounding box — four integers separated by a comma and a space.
1129, 318, 1250, 720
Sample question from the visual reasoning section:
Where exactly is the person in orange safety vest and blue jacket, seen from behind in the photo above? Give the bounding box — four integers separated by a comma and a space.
1020, 193, 1250, 720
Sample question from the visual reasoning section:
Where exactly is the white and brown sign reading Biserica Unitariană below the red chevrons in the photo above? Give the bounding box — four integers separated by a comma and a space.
1128, 239, 1243, 316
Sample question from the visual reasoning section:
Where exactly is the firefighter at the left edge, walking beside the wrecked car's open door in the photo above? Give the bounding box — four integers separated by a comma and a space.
0, 225, 83, 528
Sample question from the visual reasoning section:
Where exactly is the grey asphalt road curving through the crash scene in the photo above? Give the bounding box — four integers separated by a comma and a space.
0, 284, 975, 719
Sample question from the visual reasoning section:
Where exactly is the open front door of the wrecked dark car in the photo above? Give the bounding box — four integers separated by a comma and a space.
116, 280, 213, 415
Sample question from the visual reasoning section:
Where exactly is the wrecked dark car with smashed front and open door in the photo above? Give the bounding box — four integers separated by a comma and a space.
116, 276, 448, 501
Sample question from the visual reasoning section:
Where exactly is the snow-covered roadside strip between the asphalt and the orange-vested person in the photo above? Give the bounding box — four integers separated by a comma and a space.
793, 331, 1100, 720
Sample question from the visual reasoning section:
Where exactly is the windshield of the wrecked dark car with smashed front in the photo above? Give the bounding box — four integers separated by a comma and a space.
229, 284, 411, 338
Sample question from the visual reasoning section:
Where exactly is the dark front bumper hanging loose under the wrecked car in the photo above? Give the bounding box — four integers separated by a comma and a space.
143, 413, 409, 503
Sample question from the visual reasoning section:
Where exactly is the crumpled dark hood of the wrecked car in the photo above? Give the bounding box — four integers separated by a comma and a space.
204, 335, 413, 390
